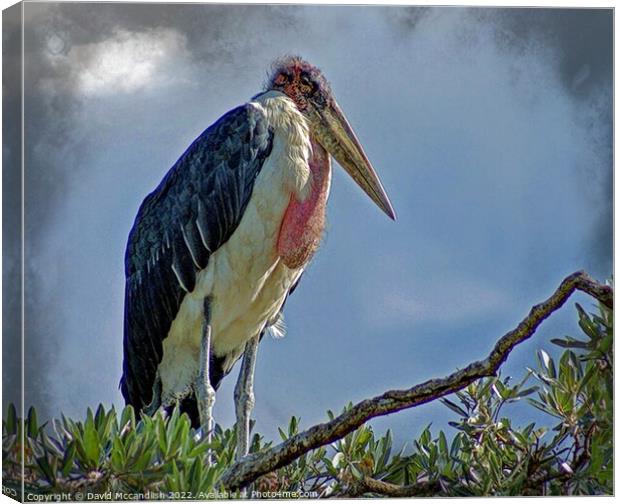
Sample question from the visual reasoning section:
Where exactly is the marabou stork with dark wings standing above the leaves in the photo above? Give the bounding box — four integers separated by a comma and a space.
121, 57, 395, 457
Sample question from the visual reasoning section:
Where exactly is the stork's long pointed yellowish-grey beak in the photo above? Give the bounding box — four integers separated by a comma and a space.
312, 100, 396, 220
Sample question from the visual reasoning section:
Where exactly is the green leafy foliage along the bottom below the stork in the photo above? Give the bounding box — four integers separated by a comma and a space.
2, 305, 613, 499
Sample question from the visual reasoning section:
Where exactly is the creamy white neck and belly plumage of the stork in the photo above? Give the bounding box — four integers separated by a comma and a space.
158, 92, 318, 404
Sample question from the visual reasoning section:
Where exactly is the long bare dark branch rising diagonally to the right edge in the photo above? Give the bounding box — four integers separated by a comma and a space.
220, 271, 613, 490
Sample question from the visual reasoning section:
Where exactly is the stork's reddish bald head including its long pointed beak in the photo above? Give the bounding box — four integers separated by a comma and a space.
267, 56, 396, 219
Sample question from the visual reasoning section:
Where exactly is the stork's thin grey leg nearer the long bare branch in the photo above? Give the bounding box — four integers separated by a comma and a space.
235, 335, 260, 460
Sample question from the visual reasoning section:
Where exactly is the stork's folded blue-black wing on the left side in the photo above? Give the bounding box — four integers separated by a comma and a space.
121, 105, 273, 409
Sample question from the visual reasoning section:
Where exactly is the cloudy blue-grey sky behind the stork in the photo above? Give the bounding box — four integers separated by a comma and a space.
3, 3, 613, 440
